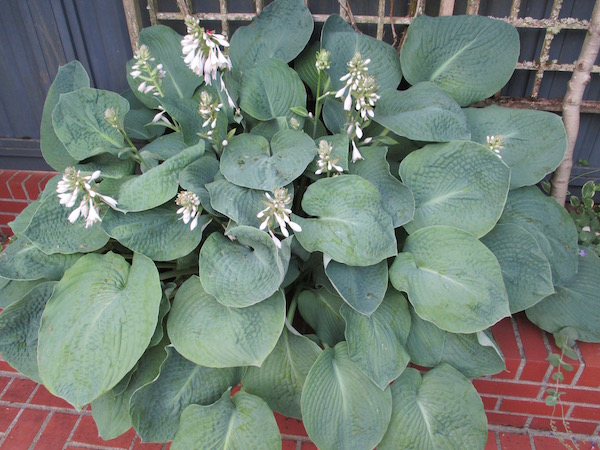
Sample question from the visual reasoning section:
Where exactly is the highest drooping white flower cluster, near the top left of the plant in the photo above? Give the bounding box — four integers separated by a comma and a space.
181, 16, 231, 84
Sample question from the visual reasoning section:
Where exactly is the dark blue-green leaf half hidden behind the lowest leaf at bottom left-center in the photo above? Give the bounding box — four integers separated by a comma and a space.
130, 347, 238, 442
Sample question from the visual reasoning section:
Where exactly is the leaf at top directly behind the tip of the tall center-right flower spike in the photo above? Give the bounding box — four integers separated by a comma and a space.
321, 14, 402, 90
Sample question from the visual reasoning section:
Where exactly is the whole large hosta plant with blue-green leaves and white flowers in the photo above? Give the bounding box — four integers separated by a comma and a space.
0, 0, 600, 450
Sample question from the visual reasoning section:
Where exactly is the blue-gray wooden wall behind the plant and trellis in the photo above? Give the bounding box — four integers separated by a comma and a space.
0, 0, 600, 184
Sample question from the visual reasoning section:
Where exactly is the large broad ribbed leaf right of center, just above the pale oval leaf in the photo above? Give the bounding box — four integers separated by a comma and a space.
400, 141, 510, 237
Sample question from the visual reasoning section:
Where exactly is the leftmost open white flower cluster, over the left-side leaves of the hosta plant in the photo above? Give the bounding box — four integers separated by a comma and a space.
56, 167, 117, 228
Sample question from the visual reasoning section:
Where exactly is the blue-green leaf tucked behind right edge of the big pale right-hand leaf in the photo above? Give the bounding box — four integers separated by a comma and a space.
482, 223, 554, 312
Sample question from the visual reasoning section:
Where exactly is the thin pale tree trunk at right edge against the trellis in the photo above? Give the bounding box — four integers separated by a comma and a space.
552, 0, 600, 205
